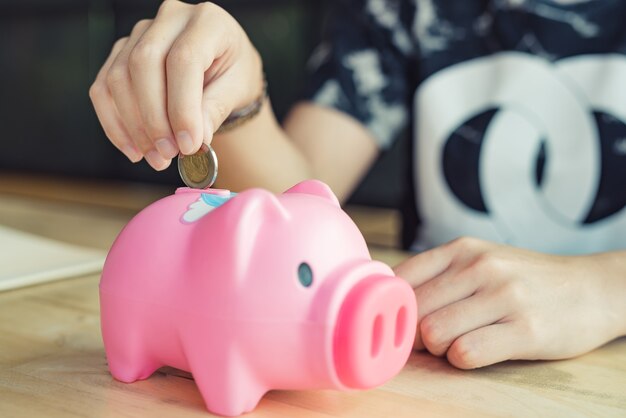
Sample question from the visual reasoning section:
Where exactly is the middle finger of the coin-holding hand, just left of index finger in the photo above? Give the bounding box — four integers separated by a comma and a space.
128, 2, 190, 160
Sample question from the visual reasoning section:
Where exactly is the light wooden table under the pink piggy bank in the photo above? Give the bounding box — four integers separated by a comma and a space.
0, 175, 626, 418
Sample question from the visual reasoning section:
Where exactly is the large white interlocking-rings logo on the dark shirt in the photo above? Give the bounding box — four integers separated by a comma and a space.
415, 52, 626, 253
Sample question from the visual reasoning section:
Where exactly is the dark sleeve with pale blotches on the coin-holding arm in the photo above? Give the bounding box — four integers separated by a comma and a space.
305, 0, 415, 149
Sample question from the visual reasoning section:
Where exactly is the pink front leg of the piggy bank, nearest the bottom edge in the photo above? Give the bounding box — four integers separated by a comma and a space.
185, 335, 267, 416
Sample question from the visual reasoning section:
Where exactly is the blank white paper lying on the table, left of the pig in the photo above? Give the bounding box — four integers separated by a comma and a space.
0, 225, 106, 291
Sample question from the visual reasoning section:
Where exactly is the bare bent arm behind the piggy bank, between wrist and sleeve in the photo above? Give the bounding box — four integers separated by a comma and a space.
213, 102, 378, 202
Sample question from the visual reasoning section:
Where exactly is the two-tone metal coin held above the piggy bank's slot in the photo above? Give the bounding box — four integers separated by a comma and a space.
178, 144, 217, 189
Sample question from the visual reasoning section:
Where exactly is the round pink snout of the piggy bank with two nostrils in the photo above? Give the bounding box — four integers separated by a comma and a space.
334, 275, 417, 389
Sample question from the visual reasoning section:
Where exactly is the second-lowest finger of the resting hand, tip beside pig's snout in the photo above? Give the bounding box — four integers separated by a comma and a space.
420, 292, 508, 356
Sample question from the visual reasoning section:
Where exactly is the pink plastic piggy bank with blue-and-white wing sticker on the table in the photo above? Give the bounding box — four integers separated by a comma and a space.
100, 180, 417, 416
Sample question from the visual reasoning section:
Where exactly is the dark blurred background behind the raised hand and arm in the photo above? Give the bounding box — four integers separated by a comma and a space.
0, 0, 408, 207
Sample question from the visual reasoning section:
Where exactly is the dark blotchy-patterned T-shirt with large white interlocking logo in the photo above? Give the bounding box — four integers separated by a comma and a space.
309, 0, 626, 253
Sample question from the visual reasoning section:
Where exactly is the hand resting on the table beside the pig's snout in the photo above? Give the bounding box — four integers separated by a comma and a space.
395, 238, 626, 369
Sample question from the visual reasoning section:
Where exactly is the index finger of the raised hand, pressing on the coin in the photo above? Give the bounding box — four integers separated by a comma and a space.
166, 3, 233, 154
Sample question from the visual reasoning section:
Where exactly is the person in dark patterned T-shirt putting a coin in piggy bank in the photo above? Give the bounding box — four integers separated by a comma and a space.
90, 0, 626, 369
